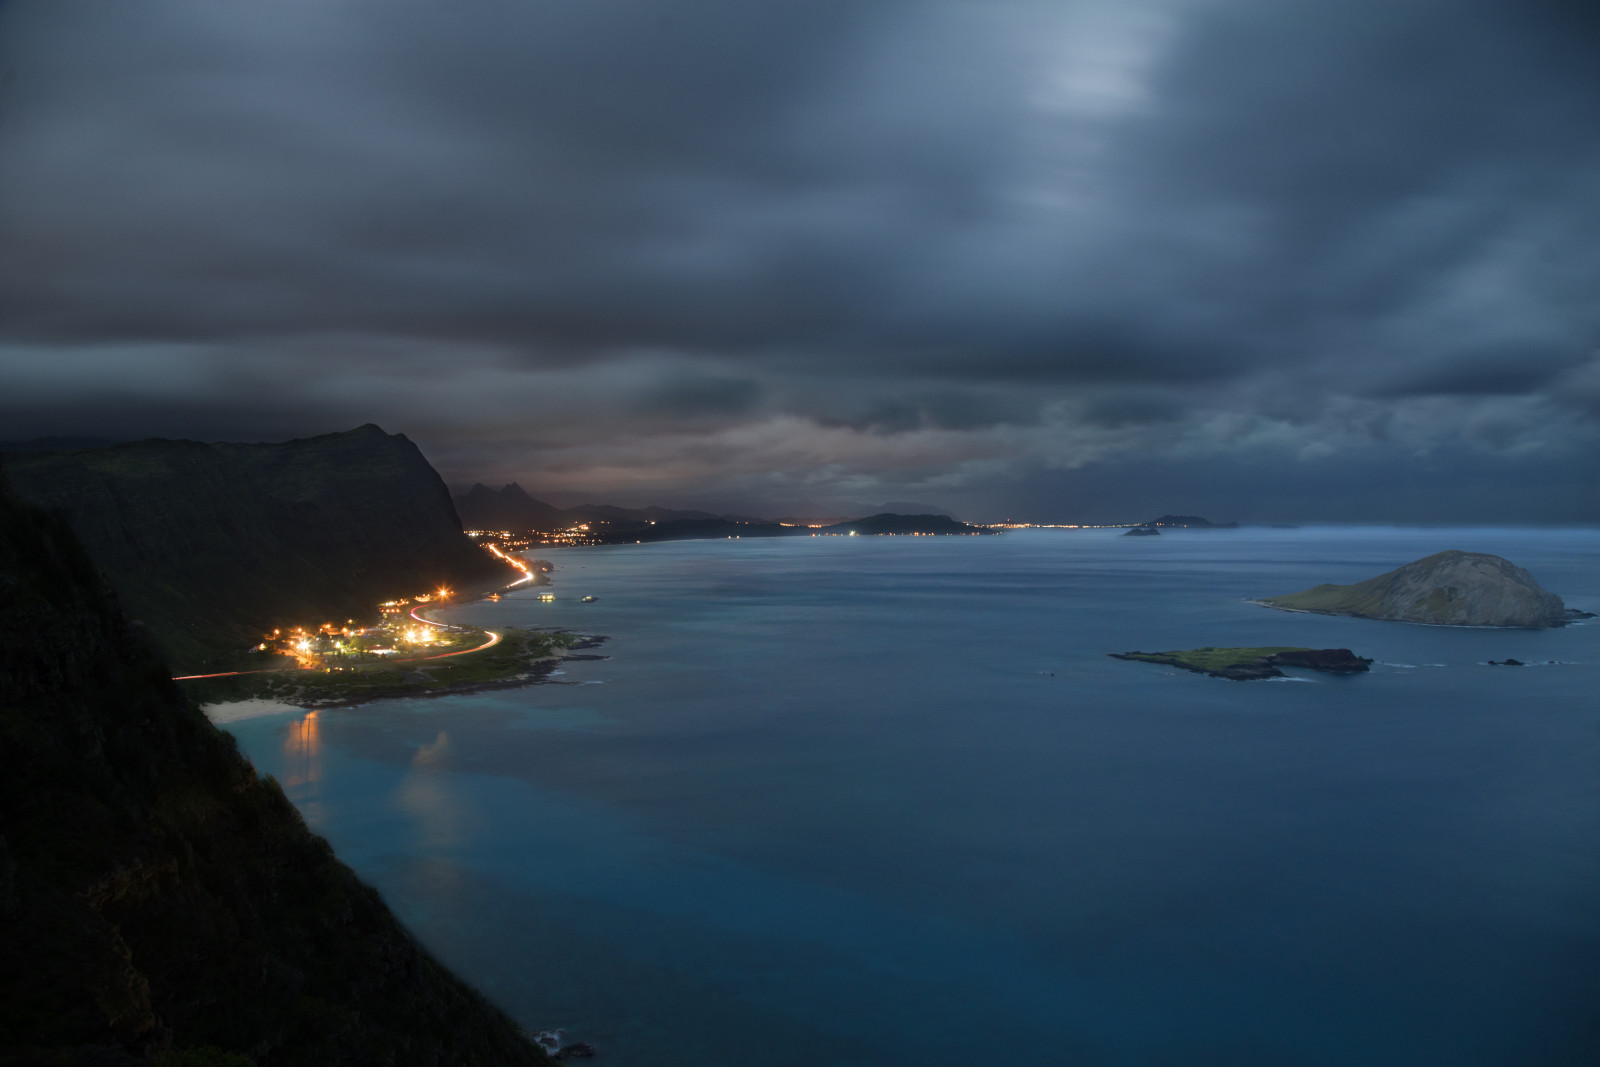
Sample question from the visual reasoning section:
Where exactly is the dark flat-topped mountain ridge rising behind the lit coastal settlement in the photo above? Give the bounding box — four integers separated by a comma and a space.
3, 426, 514, 672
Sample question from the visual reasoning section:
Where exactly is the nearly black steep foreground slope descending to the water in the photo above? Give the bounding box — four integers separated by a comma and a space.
0, 498, 547, 1067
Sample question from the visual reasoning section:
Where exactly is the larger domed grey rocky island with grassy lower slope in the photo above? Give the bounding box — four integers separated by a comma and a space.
1256, 550, 1592, 629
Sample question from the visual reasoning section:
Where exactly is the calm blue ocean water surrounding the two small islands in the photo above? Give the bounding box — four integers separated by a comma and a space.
229, 528, 1600, 1067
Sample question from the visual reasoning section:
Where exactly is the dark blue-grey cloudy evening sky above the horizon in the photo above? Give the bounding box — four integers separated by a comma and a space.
0, 0, 1600, 523
